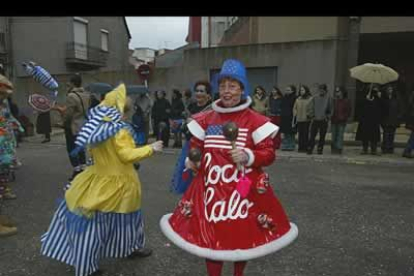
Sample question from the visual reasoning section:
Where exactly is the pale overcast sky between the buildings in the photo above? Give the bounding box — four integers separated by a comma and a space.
126, 16, 189, 49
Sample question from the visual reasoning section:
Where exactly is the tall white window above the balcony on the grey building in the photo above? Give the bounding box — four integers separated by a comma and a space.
73, 17, 88, 59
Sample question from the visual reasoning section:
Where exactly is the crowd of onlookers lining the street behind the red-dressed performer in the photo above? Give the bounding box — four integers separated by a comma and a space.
145, 81, 414, 158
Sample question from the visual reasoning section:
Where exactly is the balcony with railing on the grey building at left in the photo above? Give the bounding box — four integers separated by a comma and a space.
66, 42, 108, 69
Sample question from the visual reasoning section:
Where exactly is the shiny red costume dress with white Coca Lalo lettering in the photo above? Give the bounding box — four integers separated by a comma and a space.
160, 97, 298, 261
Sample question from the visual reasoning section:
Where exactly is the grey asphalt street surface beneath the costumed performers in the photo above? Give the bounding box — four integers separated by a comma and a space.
0, 136, 414, 276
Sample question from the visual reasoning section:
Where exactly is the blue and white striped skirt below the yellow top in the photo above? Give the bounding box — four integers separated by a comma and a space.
41, 201, 145, 276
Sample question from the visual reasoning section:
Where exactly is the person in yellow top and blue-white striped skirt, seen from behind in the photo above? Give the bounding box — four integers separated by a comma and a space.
41, 84, 162, 276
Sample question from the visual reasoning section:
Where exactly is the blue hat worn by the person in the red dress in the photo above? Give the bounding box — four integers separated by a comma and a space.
215, 59, 250, 99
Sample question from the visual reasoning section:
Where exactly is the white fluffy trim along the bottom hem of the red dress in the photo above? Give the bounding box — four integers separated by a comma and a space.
160, 214, 298, 262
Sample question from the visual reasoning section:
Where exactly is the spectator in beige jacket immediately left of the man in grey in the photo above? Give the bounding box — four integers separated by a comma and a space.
293, 85, 312, 152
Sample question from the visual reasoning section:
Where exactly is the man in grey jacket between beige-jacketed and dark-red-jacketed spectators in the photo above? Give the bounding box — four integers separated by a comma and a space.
308, 84, 332, 154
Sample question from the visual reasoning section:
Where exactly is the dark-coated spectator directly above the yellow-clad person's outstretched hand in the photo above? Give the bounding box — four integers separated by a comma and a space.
152, 91, 171, 147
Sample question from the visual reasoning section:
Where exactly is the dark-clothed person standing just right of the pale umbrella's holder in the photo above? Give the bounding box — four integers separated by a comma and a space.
381, 85, 402, 154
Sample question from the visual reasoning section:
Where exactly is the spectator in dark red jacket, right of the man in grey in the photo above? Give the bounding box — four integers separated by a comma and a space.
331, 86, 352, 154
